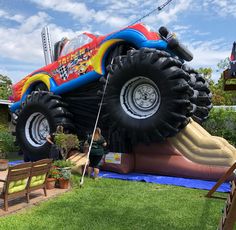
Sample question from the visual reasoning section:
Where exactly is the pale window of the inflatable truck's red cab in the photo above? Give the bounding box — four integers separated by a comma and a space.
60, 34, 92, 56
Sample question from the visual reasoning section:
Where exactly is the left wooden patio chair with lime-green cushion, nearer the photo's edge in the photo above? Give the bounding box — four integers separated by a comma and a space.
0, 162, 32, 211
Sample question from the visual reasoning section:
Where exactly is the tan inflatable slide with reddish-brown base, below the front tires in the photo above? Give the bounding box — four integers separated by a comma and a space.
134, 120, 236, 180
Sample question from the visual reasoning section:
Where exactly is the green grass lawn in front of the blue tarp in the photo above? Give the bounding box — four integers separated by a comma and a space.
0, 177, 227, 230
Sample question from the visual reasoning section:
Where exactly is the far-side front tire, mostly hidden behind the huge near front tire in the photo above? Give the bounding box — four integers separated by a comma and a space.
183, 65, 212, 124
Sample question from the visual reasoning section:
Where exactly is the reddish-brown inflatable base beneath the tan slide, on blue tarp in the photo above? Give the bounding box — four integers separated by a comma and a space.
135, 141, 229, 180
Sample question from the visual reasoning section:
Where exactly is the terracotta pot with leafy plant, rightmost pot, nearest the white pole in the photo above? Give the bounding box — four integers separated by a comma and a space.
53, 160, 75, 189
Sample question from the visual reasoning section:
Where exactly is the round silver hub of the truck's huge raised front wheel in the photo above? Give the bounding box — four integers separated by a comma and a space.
120, 76, 160, 119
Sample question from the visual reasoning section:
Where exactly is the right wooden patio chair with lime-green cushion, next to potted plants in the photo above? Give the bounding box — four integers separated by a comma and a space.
27, 159, 52, 200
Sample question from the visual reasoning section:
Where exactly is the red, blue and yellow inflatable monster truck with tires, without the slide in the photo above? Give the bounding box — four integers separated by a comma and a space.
11, 24, 211, 161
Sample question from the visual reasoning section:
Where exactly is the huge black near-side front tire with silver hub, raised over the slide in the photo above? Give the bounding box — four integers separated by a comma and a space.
104, 49, 195, 143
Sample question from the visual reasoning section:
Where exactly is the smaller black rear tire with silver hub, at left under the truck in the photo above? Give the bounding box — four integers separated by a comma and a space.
16, 91, 73, 161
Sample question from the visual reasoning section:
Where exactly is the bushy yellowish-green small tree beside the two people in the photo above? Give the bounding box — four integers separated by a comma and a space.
55, 133, 80, 160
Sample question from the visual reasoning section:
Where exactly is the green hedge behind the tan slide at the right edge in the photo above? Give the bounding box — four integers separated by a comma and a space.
203, 108, 236, 146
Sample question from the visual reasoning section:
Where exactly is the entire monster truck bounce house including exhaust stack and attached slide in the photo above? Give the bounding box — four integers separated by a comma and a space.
11, 23, 236, 179
